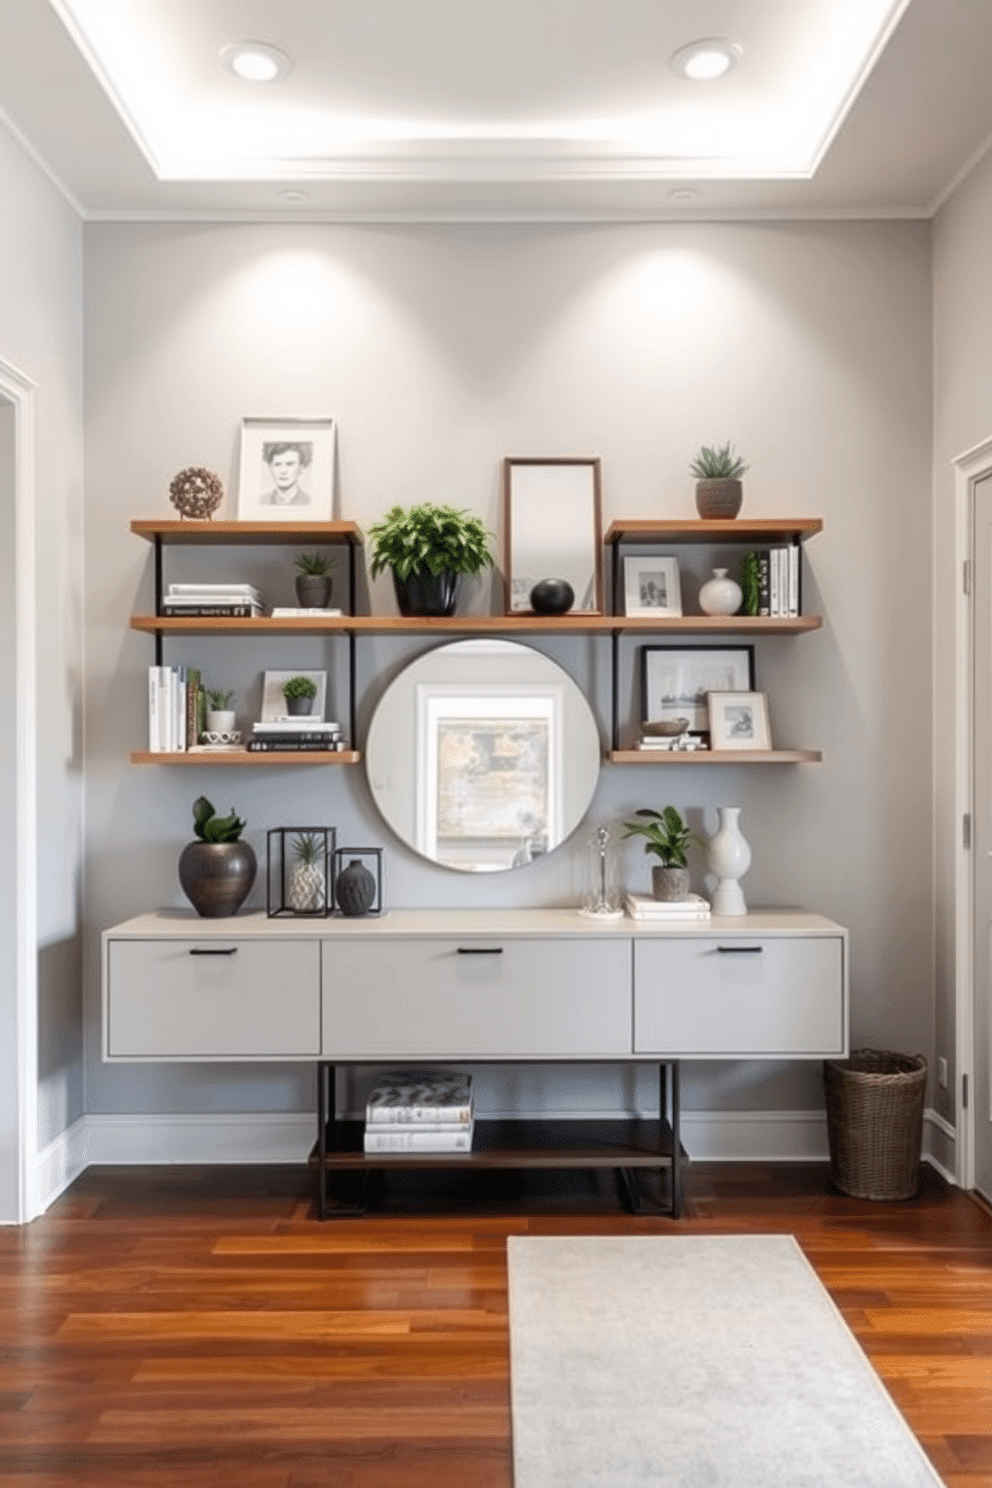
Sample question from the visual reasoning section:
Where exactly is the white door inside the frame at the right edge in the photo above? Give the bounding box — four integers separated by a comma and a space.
971, 472, 992, 1201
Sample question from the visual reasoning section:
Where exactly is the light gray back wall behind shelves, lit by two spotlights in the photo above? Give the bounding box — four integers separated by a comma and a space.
85, 222, 933, 1112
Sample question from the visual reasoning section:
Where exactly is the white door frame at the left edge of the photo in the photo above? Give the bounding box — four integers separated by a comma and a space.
0, 359, 40, 1225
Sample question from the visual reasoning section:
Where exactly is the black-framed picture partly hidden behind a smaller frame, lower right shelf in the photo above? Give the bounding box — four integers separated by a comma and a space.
641, 646, 754, 734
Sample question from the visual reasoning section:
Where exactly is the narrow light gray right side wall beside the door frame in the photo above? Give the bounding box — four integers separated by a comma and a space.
933, 153, 992, 1120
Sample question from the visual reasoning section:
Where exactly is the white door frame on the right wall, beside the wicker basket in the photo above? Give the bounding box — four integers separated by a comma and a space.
952, 437, 992, 1189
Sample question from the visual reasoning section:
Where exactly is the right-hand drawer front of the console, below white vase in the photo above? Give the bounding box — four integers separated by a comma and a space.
634, 934, 846, 1058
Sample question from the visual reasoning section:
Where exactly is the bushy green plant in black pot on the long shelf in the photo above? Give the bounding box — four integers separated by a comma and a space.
369, 501, 494, 615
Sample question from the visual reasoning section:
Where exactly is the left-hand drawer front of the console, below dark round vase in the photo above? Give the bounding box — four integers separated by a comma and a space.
106, 936, 320, 1059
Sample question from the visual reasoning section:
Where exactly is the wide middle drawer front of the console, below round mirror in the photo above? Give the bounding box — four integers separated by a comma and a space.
323, 937, 631, 1061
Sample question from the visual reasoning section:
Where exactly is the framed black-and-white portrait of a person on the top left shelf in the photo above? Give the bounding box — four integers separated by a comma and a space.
238, 418, 335, 522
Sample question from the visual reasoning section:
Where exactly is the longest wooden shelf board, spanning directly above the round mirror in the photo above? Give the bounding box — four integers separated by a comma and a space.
131, 615, 822, 635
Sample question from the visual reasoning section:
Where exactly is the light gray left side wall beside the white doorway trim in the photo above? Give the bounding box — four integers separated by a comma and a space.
0, 128, 83, 1146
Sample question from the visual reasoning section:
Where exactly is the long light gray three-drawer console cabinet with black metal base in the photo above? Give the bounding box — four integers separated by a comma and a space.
103, 909, 848, 1217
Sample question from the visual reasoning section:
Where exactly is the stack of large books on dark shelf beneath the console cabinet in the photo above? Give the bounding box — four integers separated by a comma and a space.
364, 1073, 476, 1152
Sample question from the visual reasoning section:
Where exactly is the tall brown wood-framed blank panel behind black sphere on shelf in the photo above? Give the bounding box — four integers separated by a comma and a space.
503, 458, 602, 615
